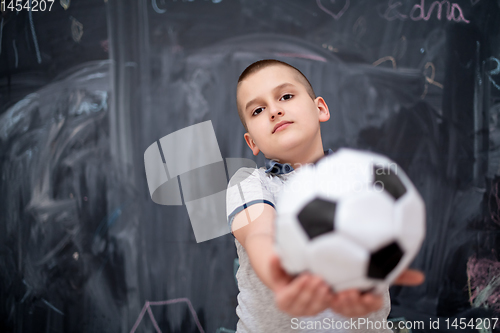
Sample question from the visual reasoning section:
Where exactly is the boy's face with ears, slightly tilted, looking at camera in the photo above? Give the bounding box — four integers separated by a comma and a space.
237, 65, 330, 161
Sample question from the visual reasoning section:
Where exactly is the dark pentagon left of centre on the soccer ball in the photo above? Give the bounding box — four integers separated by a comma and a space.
298, 198, 337, 239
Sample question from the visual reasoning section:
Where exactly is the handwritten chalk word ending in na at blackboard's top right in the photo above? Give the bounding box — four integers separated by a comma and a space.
383, 0, 470, 23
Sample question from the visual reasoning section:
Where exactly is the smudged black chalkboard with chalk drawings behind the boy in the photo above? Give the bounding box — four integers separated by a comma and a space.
0, 0, 500, 332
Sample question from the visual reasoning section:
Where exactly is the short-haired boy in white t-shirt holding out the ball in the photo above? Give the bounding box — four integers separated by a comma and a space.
227, 60, 423, 333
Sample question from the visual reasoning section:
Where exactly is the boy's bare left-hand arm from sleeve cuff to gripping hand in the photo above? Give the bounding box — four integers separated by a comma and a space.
232, 203, 333, 316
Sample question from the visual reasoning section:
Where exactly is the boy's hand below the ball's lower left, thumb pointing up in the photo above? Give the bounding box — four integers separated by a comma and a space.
271, 256, 333, 317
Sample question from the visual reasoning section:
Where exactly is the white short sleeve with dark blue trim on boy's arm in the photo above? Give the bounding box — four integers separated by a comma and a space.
226, 168, 274, 233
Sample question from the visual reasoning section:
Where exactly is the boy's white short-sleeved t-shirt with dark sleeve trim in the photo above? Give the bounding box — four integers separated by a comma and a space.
226, 168, 392, 333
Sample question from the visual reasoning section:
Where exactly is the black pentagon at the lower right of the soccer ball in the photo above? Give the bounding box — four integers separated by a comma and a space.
368, 242, 403, 279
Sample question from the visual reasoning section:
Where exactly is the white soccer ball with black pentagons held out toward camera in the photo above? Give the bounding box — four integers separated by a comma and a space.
275, 148, 425, 292
